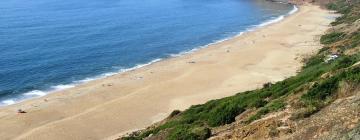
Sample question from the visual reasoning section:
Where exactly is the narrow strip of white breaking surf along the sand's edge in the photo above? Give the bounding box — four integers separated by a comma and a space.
0, 2, 298, 108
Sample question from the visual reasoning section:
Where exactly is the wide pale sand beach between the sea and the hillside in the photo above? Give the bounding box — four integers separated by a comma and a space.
0, 5, 332, 140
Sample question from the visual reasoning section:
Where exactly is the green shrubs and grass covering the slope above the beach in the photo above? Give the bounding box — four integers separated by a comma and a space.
122, 0, 360, 140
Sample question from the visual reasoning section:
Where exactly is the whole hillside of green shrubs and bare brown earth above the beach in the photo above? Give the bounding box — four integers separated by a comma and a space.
119, 0, 360, 140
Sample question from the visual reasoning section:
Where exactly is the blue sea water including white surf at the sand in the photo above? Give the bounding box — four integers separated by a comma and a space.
0, 0, 294, 105
